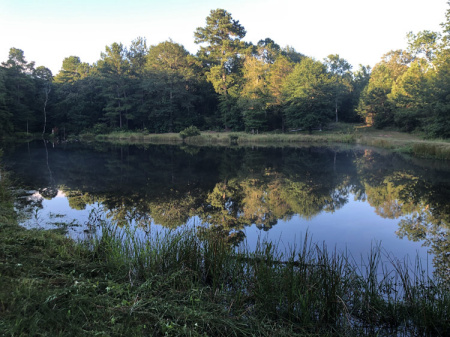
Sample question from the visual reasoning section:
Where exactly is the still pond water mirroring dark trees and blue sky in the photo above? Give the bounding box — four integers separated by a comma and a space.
3, 141, 450, 276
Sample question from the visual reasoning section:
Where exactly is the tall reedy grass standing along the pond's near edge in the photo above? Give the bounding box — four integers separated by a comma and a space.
89, 219, 450, 336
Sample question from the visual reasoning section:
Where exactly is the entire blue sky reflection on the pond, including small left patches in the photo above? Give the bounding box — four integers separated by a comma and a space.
23, 191, 432, 272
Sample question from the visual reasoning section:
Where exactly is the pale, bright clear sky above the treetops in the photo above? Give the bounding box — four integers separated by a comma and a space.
0, 0, 450, 75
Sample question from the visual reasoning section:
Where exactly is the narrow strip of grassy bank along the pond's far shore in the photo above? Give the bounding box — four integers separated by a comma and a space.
89, 123, 450, 160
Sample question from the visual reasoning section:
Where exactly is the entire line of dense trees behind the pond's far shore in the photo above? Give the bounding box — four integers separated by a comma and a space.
0, 2, 450, 138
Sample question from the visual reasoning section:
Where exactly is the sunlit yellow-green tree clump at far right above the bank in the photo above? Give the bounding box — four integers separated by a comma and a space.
358, 11, 450, 138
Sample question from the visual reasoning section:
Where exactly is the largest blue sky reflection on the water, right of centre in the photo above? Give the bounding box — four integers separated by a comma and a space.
241, 195, 431, 271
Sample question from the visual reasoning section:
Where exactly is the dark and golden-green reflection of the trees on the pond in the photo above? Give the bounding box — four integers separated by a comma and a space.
4, 142, 450, 278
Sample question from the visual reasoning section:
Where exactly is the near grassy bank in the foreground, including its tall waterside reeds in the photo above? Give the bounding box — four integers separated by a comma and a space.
0, 201, 450, 336
